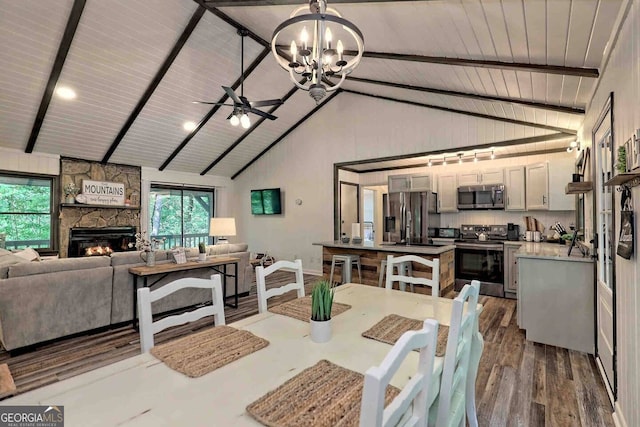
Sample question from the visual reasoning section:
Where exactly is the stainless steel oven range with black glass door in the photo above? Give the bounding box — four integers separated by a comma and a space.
455, 241, 504, 297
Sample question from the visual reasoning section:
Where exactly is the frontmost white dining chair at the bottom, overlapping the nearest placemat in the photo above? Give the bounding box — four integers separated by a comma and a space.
360, 319, 438, 427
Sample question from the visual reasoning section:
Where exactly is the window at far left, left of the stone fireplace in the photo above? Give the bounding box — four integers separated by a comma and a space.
0, 174, 55, 249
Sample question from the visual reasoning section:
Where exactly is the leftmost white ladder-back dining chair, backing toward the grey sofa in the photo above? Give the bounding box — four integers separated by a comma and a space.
138, 274, 225, 353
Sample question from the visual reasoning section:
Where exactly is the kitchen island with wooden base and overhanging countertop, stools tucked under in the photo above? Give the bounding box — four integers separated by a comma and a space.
314, 241, 455, 295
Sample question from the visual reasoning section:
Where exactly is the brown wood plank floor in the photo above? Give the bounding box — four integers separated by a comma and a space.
0, 274, 614, 427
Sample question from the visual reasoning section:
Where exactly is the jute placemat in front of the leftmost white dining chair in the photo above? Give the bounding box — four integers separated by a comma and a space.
151, 325, 269, 378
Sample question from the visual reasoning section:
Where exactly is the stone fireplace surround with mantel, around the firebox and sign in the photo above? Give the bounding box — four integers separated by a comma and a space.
58, 158, 141, 258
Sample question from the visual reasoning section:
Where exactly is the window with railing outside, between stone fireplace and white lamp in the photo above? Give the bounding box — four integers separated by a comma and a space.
149, 185, 214, 249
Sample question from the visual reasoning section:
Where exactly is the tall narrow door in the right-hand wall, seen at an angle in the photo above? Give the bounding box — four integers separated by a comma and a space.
593, 95, 617, 401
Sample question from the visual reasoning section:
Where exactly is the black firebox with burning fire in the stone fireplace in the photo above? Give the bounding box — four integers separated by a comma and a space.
68, 227, 136, 258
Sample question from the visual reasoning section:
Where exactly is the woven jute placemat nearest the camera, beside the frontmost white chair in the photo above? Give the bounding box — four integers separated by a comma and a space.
247, 360, 400, 427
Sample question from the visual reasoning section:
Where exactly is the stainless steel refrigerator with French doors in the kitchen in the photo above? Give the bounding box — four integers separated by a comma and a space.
384, 191, 440, 244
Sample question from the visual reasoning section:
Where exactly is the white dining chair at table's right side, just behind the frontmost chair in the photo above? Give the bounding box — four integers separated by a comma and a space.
429, 280, 482, 427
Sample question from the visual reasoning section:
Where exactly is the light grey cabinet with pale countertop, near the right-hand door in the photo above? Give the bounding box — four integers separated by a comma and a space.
515, 242, 595, 354
